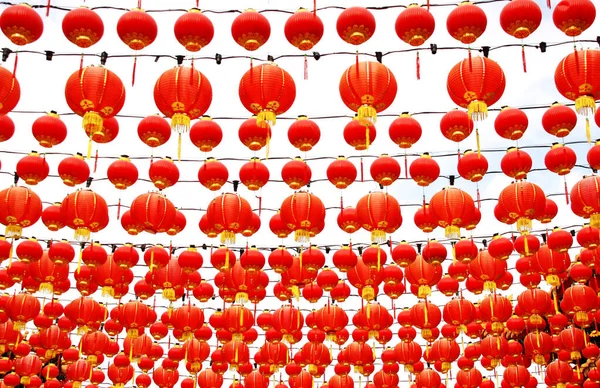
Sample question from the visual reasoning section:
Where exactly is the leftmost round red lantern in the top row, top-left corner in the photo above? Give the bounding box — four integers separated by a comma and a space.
0, 4, 44, 46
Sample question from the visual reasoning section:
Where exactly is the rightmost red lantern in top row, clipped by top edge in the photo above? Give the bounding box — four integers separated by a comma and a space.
552, 0, 596, 37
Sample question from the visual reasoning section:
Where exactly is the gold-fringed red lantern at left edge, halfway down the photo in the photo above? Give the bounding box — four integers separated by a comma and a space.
0, 186, 42, 238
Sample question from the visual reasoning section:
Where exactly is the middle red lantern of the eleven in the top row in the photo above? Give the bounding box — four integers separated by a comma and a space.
284, 8, 324, 51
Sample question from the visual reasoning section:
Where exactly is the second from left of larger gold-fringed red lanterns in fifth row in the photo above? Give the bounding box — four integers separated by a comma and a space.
60, 189, 108, 241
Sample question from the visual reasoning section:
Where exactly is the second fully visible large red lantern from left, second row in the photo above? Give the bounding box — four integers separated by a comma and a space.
154, 66, 212, 135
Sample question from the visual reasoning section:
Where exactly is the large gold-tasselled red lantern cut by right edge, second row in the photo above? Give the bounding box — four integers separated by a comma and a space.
554, 49, 600, 142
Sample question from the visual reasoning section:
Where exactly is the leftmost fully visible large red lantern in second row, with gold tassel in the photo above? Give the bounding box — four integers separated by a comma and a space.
65, 66, 125, 145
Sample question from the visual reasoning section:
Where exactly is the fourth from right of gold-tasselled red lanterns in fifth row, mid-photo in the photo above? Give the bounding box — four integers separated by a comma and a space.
356, 192, 402, 243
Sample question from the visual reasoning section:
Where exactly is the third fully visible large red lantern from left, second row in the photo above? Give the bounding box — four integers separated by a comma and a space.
239, 62, 296, 126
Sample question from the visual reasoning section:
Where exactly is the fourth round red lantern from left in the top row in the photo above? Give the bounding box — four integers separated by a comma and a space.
175, 8, 215, 52
